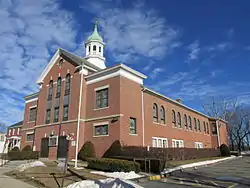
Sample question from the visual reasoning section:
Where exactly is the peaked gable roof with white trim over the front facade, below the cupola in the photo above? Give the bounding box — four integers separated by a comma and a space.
36, 48, 101, 84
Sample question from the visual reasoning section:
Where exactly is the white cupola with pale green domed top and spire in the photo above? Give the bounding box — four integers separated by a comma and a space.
85, 21, 106, 69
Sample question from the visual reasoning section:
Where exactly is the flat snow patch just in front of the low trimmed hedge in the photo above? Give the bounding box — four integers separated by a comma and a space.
90, 171, 143, 180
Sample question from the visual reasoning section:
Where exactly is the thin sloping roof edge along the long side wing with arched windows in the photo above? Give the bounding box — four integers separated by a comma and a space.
143, 87, 227, 123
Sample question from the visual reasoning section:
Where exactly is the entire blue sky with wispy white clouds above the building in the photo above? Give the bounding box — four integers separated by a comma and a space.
0, 0, 250, 125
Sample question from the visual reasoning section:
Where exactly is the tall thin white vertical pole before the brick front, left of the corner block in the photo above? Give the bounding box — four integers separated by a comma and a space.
75, 62, 83, 168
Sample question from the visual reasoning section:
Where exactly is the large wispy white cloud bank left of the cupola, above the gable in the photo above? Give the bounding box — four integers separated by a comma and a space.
0, 0, 77, 124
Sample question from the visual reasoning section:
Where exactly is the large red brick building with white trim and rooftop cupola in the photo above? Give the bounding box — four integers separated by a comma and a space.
21, 21, 227, 159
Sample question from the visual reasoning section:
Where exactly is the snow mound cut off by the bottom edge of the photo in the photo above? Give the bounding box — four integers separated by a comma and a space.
67, 178, 143, 188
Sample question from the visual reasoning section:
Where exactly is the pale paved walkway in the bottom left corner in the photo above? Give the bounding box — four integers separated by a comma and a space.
0, 161, 35, 188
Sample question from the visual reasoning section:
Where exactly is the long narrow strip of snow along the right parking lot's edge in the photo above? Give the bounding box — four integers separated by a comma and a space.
162, 156, 239, 174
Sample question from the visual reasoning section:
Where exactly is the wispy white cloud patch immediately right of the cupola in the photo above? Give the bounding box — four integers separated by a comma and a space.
84, 1, 181, 63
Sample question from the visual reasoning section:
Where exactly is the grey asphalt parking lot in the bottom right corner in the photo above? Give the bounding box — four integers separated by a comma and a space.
138, 156, 250, 188
